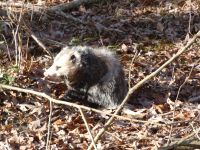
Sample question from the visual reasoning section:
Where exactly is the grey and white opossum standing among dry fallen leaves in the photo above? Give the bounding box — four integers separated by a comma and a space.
44, 46, 128, 108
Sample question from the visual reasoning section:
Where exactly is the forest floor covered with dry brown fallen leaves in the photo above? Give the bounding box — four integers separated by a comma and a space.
0, 0, 200, 150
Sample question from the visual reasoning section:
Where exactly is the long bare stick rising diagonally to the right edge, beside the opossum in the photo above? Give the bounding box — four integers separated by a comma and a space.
88, 31, 200, 150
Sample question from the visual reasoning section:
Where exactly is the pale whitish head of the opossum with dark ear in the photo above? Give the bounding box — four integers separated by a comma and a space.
44, 47, 88, 84
